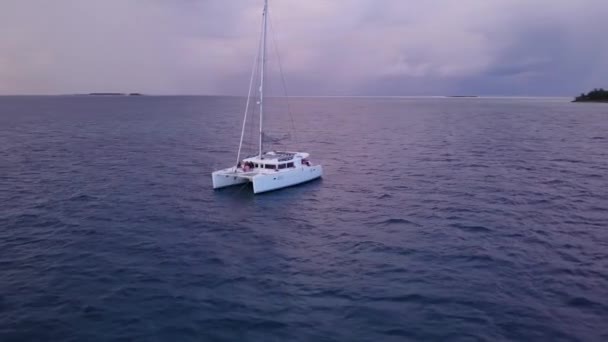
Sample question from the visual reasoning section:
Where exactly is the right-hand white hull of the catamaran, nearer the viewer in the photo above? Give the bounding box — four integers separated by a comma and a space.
252, 165, 323, 194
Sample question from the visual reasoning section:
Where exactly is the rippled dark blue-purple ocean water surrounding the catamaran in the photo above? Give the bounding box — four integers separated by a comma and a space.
0, 96, 608, 341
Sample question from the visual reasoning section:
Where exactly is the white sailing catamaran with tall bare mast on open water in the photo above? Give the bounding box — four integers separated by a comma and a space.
211, 0, 323, 194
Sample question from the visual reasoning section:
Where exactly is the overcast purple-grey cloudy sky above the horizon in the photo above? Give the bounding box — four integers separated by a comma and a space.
0, 0, 608, 96
